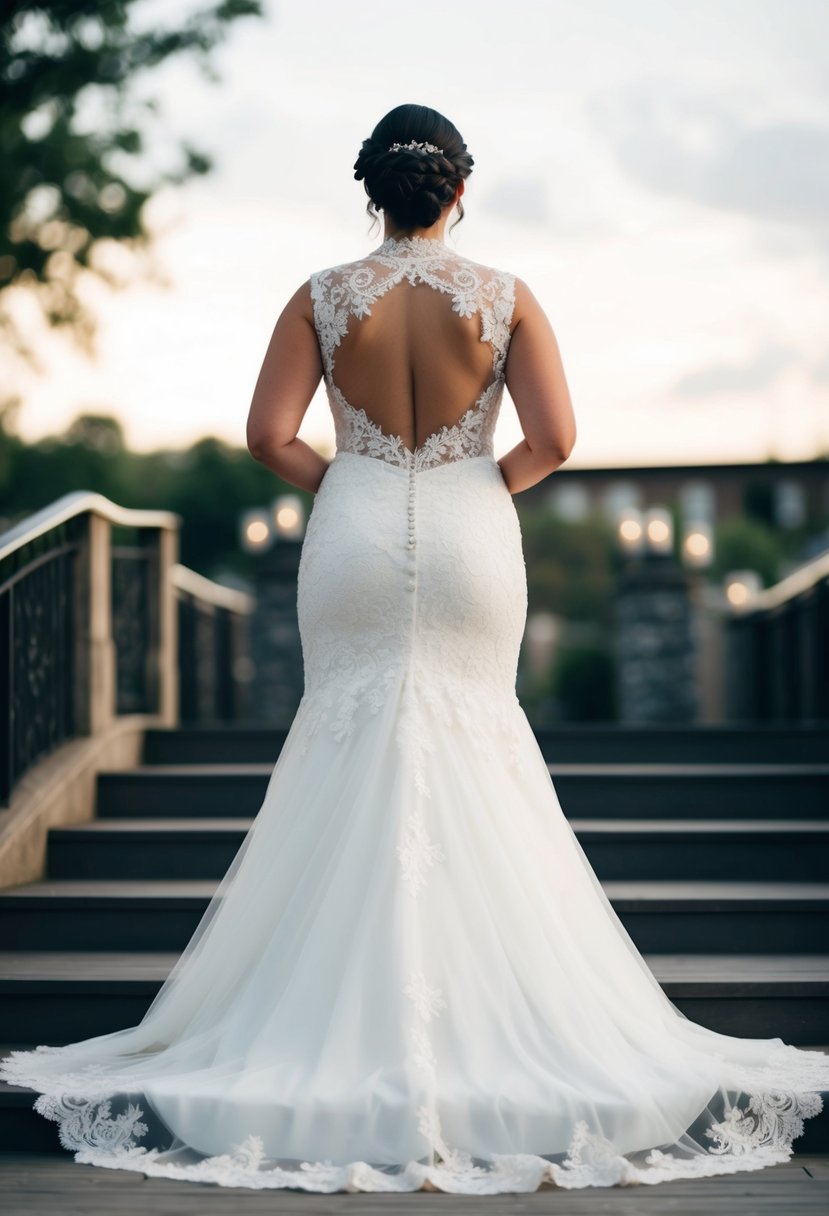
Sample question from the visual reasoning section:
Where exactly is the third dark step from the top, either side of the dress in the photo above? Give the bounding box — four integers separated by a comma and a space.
47, 816, 829, 882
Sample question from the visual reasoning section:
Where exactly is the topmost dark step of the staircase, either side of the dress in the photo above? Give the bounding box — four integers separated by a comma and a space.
143, 722, 829, 765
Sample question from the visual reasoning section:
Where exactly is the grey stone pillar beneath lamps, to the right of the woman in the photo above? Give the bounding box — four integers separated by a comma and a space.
616, 554, 699, 722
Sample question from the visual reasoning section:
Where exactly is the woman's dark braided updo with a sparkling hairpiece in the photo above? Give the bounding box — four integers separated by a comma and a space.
354, 105, 475, 229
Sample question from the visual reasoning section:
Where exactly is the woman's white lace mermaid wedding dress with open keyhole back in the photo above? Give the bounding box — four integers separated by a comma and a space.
0, 237, 829, 1194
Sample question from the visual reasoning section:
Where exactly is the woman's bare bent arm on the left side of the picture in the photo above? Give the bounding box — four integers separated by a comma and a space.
241, 282, 329, 494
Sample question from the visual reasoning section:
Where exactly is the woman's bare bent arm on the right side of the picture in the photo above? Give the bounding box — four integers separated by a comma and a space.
498, 278, 576, 494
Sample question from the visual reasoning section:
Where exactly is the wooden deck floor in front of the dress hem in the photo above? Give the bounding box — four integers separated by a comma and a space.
0, 1153, 829, 1216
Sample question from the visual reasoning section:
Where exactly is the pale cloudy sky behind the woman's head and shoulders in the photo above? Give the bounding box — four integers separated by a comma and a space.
6, 0, 829, 467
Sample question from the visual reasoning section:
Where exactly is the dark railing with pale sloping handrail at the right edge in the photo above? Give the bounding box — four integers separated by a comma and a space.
726, 553, 829, 724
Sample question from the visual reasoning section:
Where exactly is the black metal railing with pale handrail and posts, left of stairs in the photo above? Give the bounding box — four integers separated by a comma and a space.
0, 490, 252, 805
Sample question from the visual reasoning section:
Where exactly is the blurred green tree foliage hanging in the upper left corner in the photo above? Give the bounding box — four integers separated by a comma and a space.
0, 0, 261, 362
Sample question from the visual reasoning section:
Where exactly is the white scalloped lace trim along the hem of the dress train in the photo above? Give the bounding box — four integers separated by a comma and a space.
0, 1055, 829, 1194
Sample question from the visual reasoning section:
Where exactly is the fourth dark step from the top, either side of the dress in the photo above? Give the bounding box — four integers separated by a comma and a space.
0, 879, 829, 955
